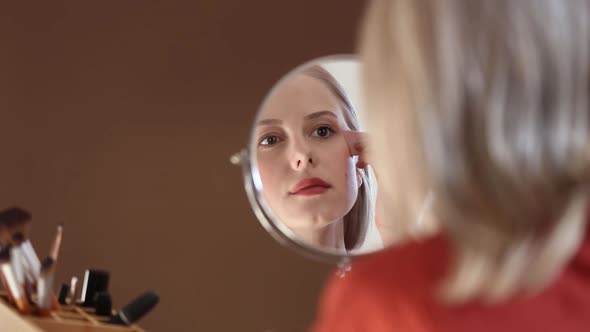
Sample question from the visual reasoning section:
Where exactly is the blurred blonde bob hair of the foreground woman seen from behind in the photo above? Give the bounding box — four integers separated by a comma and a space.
360, 0, 590, 302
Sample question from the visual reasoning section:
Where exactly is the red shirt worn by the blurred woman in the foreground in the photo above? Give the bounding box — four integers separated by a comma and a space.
312, 224, 590, 332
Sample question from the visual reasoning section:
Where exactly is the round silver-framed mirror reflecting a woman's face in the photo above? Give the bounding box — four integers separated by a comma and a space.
239, 55, 383, 261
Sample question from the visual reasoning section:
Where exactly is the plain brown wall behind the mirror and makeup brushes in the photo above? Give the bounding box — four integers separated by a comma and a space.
0, 0, 363, 331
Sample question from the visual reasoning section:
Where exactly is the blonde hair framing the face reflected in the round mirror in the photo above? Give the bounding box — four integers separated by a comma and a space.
303, 65, 375, 251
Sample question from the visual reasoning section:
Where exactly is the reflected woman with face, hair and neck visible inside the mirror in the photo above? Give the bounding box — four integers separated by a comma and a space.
255, 66, 380, 252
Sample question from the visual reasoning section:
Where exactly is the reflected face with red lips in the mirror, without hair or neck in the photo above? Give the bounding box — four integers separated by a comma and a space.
255, 74, 360, 229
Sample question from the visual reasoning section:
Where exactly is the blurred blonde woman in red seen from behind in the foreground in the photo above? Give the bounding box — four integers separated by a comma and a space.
314, 0, 590, 332
